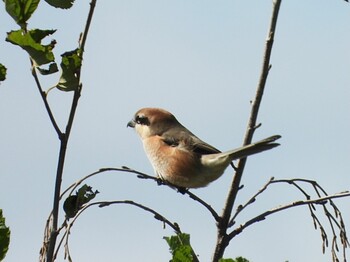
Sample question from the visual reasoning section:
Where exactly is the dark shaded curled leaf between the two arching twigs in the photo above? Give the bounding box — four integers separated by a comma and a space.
63, 184, 99, 218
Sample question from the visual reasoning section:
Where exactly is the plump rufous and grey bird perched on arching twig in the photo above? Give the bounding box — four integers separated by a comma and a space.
127, 108, 281, 189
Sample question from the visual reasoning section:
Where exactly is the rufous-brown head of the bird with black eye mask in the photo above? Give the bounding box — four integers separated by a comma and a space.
127, 108, 181, 139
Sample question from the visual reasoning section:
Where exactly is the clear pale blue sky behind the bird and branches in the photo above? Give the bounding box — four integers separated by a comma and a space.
0, 0, 350, 262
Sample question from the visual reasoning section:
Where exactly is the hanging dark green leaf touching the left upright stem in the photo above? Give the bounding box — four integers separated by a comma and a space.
57, 48, 82, 92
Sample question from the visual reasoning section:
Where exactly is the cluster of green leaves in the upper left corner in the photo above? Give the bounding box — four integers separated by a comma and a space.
0, 0, 82, 91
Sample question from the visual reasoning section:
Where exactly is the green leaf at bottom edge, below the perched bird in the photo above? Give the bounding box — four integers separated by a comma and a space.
164, 233, 193, 262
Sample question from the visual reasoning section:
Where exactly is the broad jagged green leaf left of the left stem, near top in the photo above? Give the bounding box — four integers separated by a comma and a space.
6, 29, 56, 66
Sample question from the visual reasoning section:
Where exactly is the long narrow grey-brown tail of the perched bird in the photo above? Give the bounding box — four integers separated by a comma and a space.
225, 135, 281, 161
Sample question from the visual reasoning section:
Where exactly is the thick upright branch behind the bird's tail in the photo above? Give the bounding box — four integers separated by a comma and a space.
213, 0, 282, 262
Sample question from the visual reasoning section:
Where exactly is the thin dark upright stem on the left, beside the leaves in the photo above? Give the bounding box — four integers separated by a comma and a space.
44, 0, 97, 262
